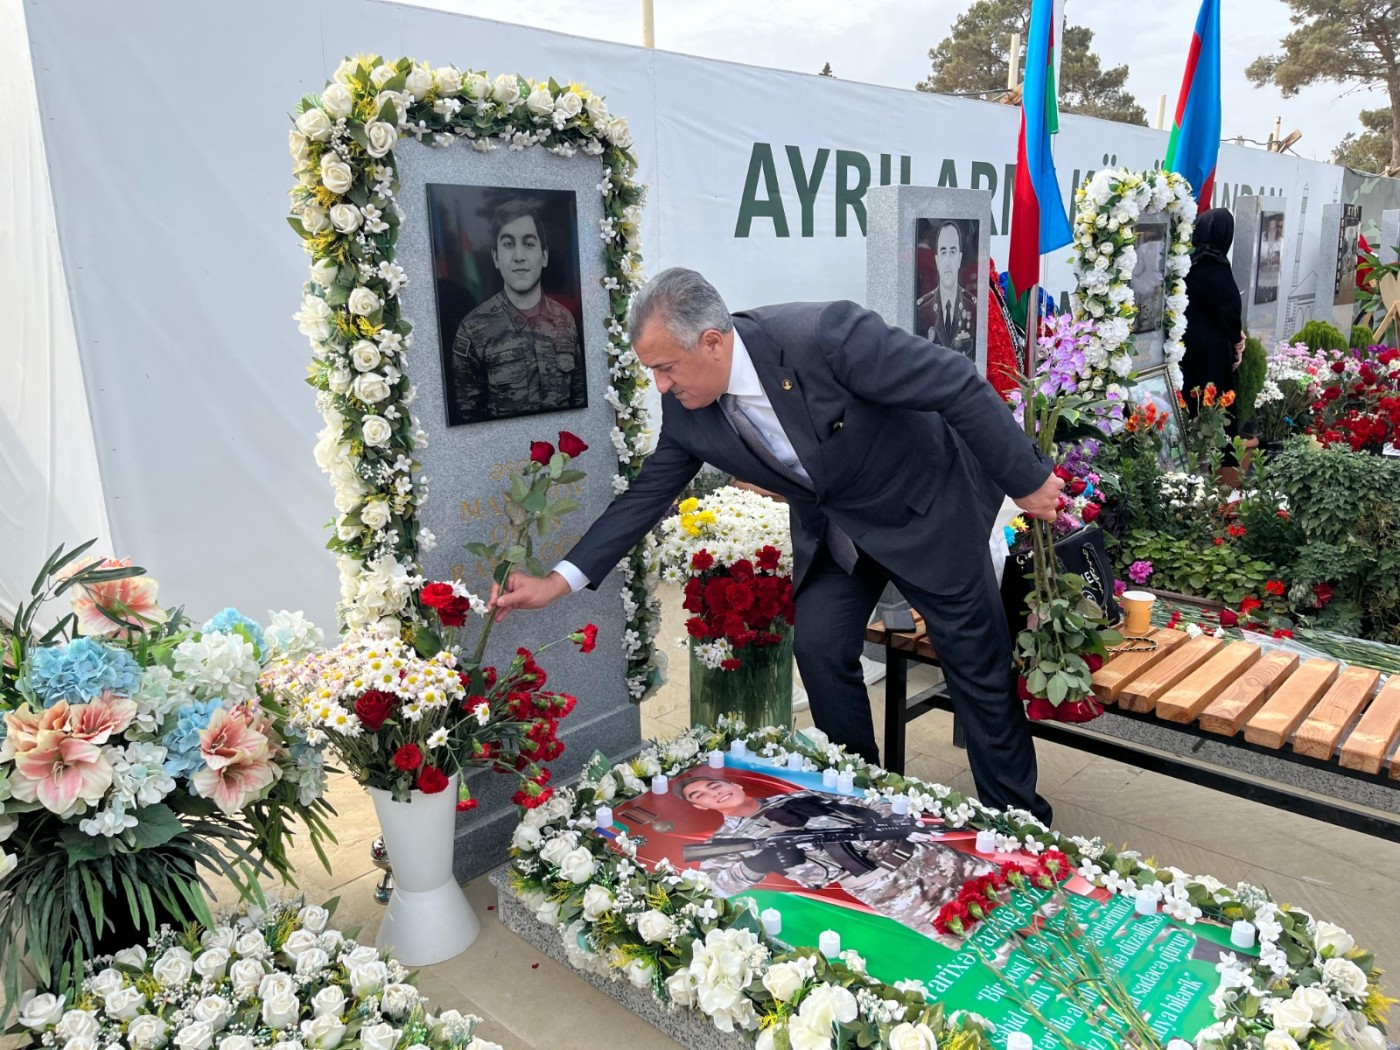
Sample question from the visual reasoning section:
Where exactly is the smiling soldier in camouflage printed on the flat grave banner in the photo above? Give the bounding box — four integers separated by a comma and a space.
678, 776, 997, 937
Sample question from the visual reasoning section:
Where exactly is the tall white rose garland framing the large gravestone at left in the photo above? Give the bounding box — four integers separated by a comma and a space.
288, 55, 659, 700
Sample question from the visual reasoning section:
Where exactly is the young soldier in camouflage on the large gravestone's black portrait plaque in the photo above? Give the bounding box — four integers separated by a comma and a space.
452, 200, 588, 423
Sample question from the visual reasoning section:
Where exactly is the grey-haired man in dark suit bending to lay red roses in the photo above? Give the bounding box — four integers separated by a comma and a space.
493, 267, 1064, 820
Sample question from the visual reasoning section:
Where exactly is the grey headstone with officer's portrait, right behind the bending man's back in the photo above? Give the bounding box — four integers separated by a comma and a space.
865, 186, 991, 375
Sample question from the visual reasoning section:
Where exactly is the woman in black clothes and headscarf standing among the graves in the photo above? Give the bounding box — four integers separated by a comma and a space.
1182, 207, 1245, 414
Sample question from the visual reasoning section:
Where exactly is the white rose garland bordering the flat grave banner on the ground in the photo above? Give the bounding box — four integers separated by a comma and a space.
511, 720, 1393, 1050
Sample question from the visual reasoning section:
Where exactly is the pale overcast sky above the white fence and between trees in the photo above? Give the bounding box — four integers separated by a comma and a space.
400, 0, 1386, 160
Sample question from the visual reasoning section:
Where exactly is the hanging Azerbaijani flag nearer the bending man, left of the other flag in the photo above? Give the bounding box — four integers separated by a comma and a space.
1007, 0, 1074, 312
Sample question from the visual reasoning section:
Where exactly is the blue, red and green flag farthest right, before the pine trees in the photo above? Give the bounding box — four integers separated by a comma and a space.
1165, 0, 1221, 209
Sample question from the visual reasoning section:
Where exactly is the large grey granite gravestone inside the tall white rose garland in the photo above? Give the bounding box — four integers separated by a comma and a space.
395, 141, 641, 881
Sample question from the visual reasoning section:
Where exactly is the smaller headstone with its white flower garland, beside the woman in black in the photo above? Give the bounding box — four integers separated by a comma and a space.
1071, 168, 1196, 388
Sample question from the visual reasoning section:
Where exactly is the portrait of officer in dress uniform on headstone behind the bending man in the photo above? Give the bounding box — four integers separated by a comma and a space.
914, 218, 981, 360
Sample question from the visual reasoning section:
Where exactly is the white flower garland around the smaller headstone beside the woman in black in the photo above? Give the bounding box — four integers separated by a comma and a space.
1070, 168, 1196, 388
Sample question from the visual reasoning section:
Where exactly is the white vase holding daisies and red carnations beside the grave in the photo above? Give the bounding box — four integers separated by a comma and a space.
368, 777, 482, 966
